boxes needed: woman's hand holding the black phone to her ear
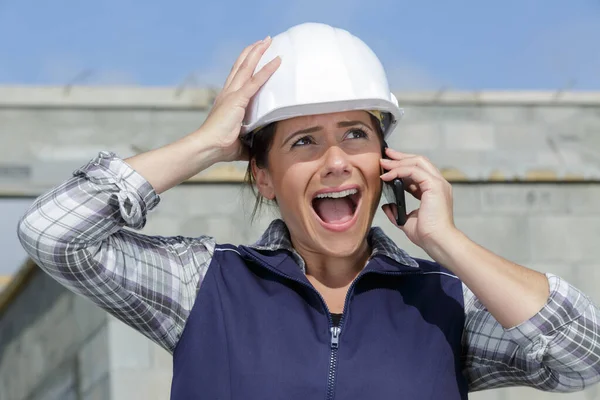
[381,148,457,252]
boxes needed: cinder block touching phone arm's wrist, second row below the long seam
[454,215,530,263]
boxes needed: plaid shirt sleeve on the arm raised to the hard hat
[18,152,215,352]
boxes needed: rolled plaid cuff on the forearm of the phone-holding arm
[506,273,591,361]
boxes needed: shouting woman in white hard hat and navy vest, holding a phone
[19,24,600,399]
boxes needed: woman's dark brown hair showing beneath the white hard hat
[244,114,383,221]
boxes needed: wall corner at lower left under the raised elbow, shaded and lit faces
[0,271,172,400]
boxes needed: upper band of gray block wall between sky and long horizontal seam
[0,87,600,194]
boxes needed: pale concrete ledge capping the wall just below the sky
[0,85,600,109]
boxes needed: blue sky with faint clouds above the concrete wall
[0,0,600,90]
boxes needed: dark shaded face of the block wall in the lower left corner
[0,273,109,400]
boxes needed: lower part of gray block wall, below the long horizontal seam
[0,183,600,400]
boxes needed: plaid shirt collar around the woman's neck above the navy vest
[249,219,419,272]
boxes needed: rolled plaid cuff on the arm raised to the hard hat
[73,151,160,229]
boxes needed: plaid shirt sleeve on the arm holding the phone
[463,274,600,392]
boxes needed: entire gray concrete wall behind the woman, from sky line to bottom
[0,88,600,400]
